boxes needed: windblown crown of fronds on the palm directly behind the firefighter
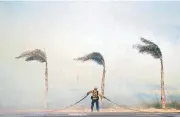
[74,52,105,66]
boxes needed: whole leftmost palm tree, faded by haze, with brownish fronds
[16,49,48,108]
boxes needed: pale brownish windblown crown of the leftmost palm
[16,49,47,63]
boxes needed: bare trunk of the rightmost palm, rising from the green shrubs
[160,58,166,109]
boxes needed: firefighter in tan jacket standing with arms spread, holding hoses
[87,87,103,112]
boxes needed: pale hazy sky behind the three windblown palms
[0,2,180,108]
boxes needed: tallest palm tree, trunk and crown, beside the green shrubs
[133,38,166,109]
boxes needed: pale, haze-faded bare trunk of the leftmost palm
[44,61,48,108]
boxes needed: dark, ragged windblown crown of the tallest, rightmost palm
[133,38,162,59]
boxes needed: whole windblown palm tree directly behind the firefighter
[74,52,106,100]
